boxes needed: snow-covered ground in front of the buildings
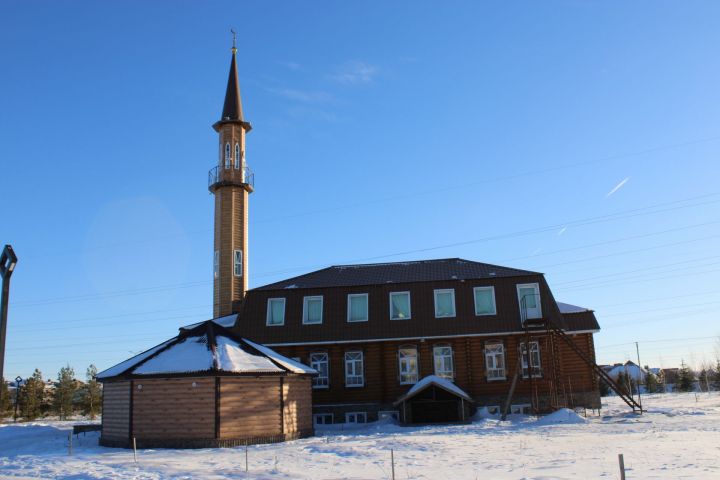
[0,393,720,480]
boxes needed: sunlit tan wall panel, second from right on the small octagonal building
[220,377,283,438]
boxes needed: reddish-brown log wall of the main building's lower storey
[275,334,596,405]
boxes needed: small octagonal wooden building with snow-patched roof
[98,315,316,448]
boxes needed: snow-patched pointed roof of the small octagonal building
[98,320,317,379]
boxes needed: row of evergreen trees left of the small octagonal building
[0,365,102,421]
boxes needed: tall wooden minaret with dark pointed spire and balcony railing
[208,38,254,317]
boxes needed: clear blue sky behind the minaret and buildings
[0,1,720,378]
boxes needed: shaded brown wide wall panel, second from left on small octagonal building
[133,377,215,440]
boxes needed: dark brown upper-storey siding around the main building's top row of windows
[235,275,564,346]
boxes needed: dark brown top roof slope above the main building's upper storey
[254,258,537,290]
